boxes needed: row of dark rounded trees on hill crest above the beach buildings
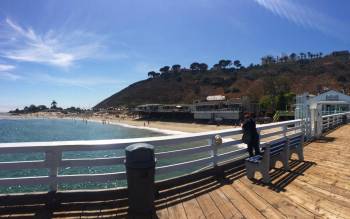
[148,59,244,78]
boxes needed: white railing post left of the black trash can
[45,150,62,192]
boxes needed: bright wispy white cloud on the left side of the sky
[0,18,109,67]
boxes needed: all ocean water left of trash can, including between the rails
[0,114,165,193]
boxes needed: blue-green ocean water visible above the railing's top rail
[0,116,164,143]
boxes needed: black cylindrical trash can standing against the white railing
[125,143,156,217]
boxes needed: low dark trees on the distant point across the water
[9,100,83,114]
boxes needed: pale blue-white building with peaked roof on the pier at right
[295,90,350,119]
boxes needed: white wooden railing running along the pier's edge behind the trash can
[0,120,305,191]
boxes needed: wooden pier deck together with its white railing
[0,112,350,218]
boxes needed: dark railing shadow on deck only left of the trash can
[0,187,127,218]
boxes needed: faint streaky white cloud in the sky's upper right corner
[254,0,347,38]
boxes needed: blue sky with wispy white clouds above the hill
[0,0,350,111]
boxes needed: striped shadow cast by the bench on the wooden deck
[252,160,317,192]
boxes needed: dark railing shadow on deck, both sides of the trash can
[0,160,245,218]
